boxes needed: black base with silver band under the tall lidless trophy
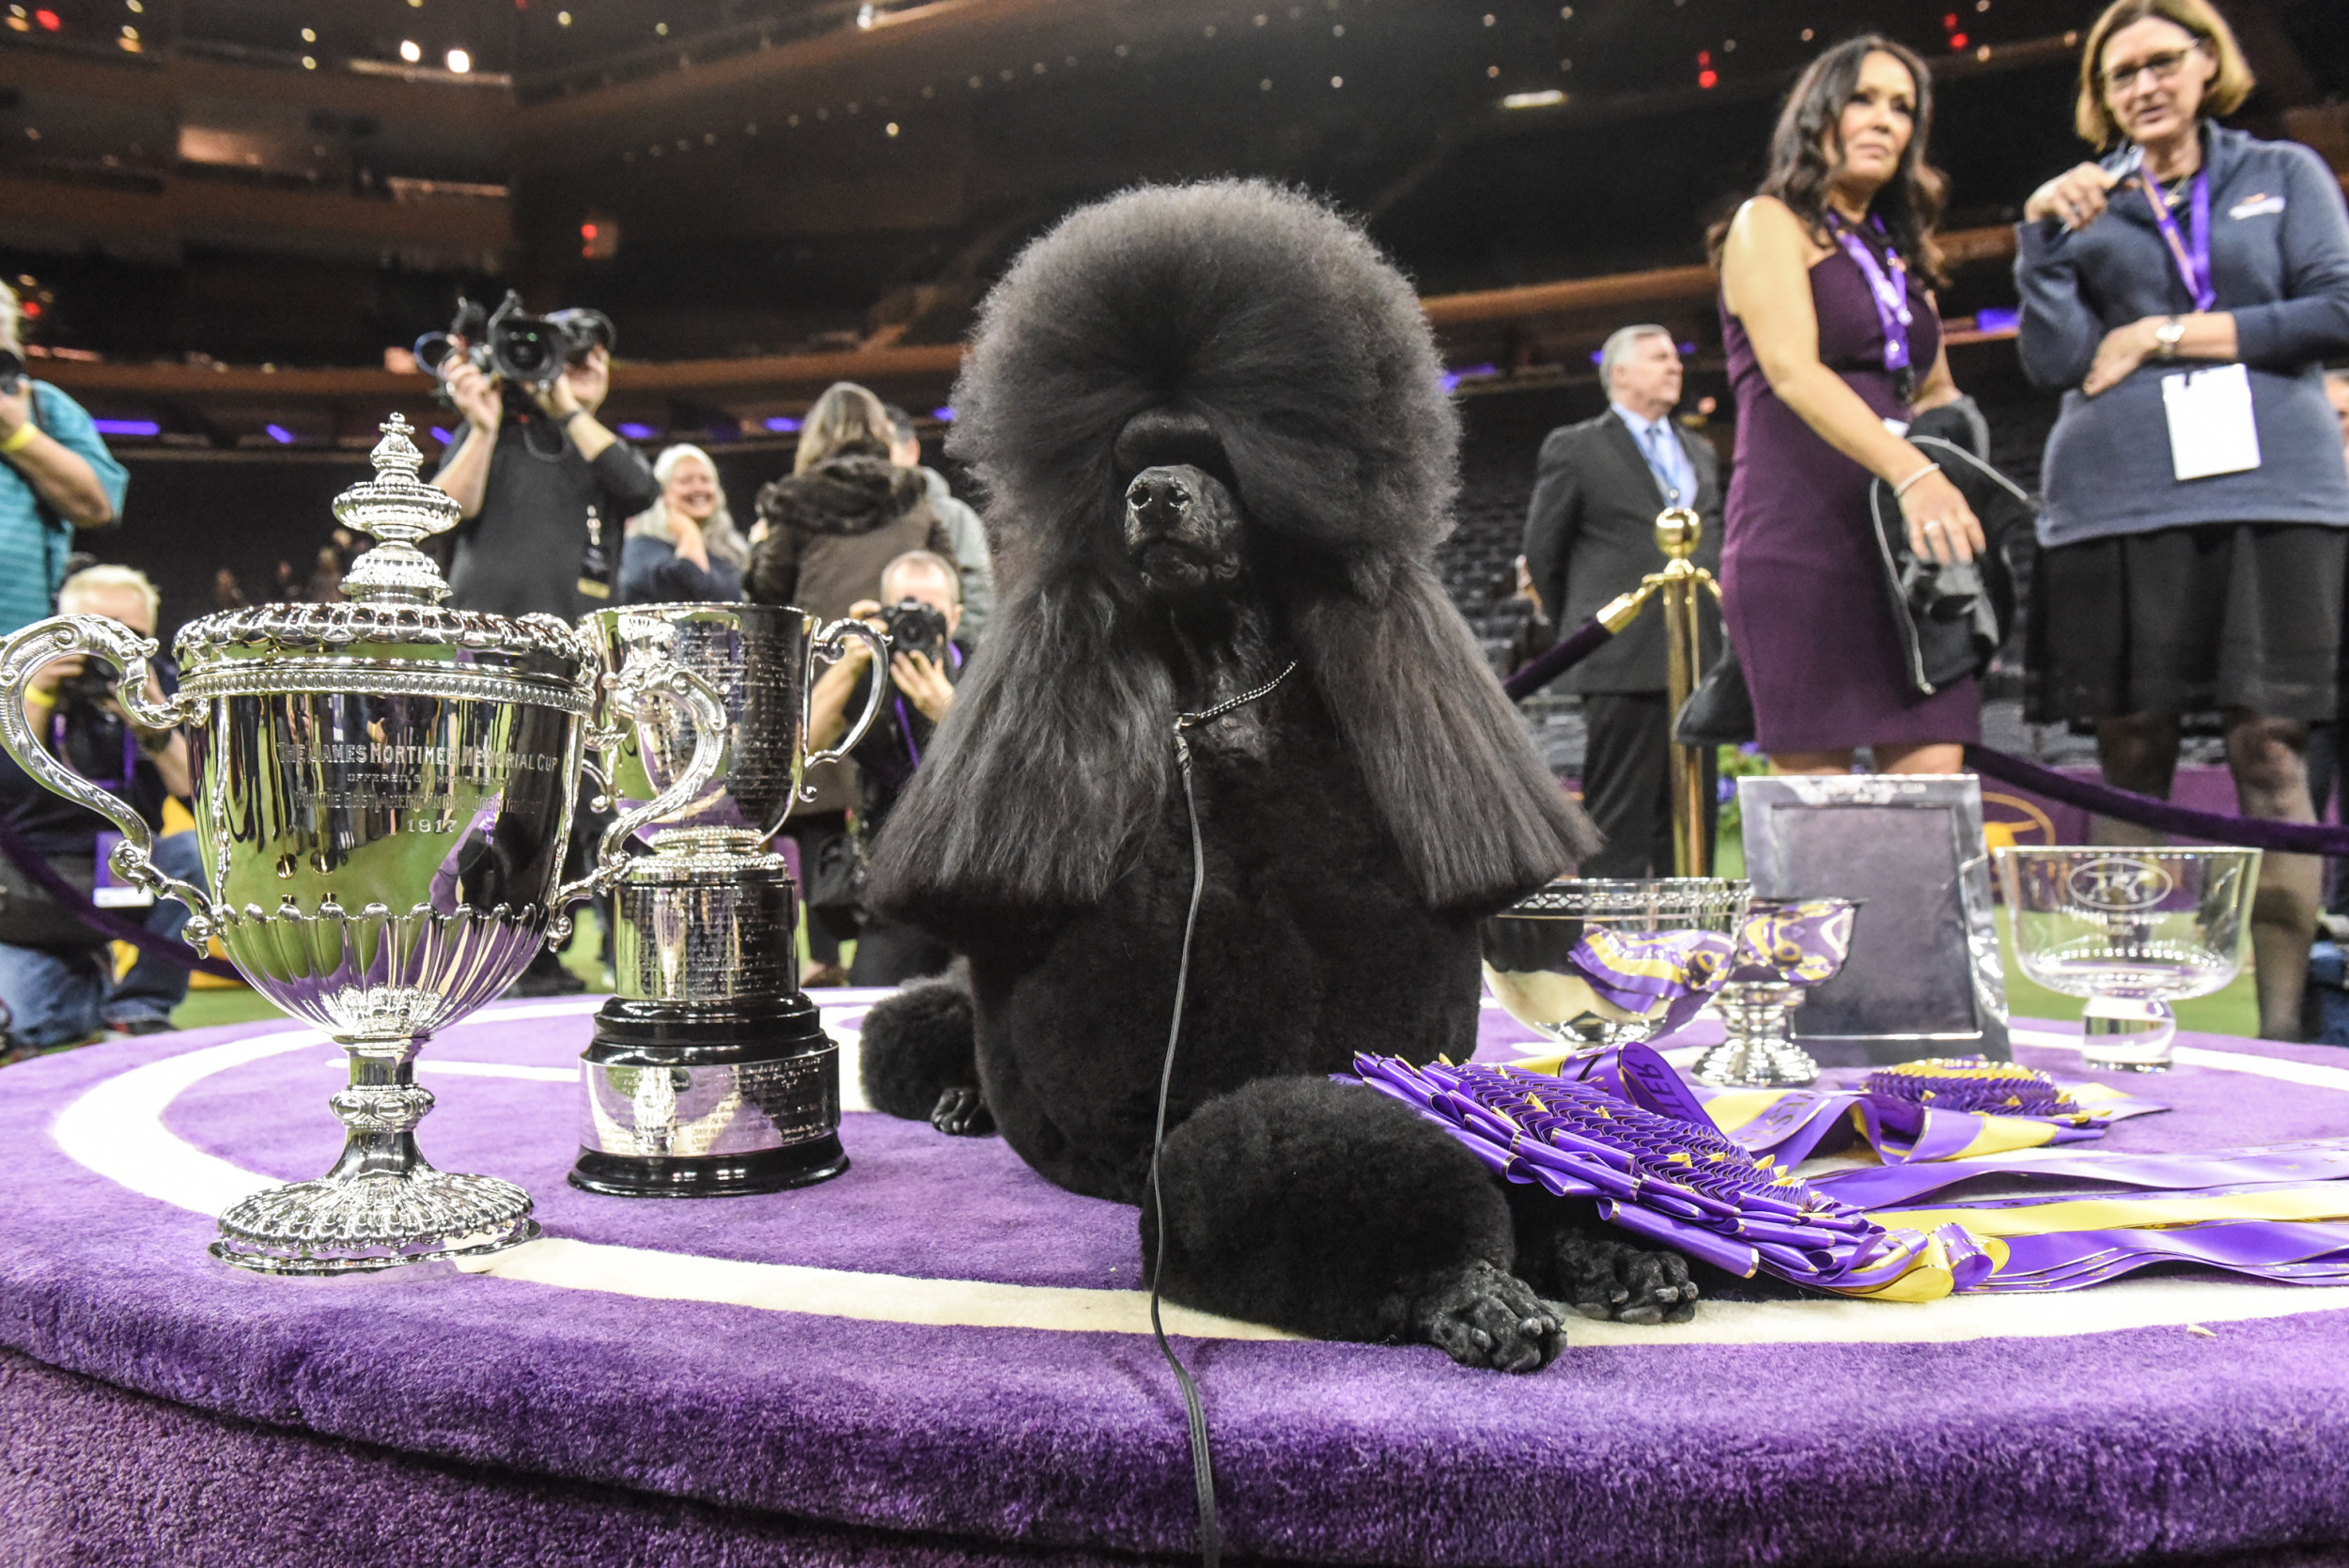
[571,990,848,1197]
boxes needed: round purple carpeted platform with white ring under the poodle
[0,993,2349,1568]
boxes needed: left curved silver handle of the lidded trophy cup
[0,615,216,951]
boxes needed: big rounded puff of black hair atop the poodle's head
[949,180,1459,594]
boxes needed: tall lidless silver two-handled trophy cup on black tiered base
[571,603,888,1197]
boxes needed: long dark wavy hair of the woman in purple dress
[1705,33,1950,287]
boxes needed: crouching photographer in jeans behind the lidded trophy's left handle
[0,566,205,1049]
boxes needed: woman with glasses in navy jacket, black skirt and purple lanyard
[2015,0,2349,1040]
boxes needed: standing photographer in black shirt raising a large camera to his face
[418,296,661,622]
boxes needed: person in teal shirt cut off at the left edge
[0,284,130,631]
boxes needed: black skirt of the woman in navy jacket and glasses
[2025,523,2349,723]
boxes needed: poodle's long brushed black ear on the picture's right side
[1290,561,1600,910]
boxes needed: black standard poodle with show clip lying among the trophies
[864,180,1696,1371]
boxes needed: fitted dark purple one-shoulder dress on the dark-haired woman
[1722,251,1983,752]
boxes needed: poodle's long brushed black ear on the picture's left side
[867,573,1174,929]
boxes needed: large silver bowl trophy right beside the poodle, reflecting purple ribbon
[1483,876,1748,1051]
